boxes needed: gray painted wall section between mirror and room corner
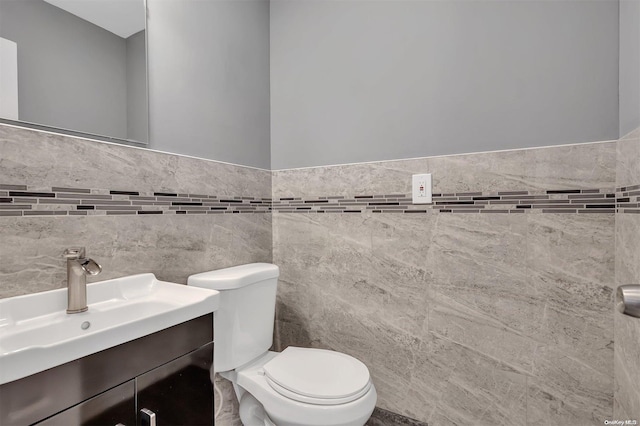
[147,0,270,169]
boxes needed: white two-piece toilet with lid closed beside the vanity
[187,263,377,426]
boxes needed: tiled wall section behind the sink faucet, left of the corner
[0,125,271,297]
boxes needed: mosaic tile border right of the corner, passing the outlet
[273,185,640,214]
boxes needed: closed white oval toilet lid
[263,346,371,404]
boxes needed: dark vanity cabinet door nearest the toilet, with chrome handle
[136,342,213,426]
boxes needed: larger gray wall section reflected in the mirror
[0,0,127,138]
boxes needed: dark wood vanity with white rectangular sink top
[0,274,219,426]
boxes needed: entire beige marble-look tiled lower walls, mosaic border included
[0,122,640,425]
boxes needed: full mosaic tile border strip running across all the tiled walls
[0,184,640,217]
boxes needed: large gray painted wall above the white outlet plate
[271,0,618,169]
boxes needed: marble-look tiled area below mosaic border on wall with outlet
[274,201,613,425]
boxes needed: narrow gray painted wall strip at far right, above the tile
[620,0,640,137]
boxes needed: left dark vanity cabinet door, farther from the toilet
[37,380,136,426]
